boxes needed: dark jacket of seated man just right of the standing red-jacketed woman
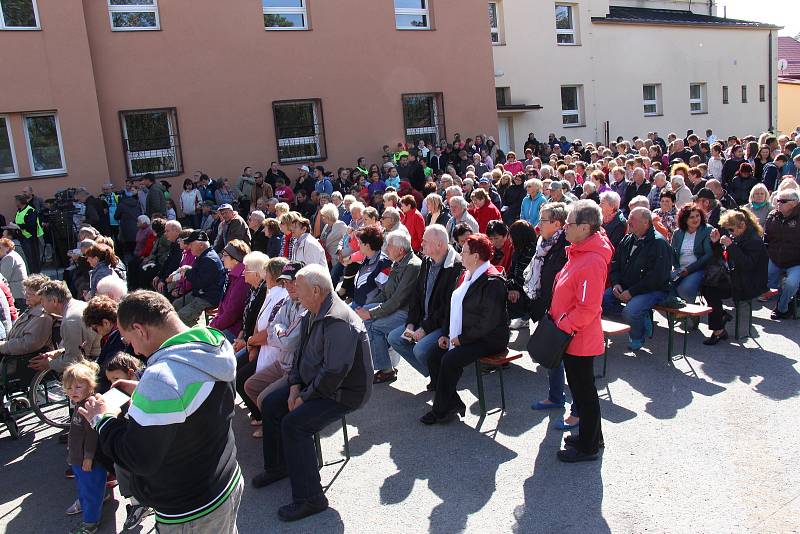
[610,226,672,297]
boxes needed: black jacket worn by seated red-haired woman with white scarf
[444,266,510,352]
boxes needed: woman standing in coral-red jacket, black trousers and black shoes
[550,200,614,462]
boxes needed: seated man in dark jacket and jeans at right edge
[764,189,800,319]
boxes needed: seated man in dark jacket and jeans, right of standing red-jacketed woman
[603,207,672,350]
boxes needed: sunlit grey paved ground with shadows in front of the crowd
[0,308,800,534]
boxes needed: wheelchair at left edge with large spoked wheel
[0,324,70,439]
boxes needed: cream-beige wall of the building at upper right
[493,0,776,149]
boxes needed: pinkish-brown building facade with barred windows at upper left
[0,0,497,217]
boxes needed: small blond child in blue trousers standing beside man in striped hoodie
[62,360,107,534]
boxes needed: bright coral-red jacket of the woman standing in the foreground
[550,232,614,356]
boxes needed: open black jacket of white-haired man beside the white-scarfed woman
[407,249,463,334]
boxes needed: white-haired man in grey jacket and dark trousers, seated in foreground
[253,264,372,521]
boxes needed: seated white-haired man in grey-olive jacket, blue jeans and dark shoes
[356,231,422,384]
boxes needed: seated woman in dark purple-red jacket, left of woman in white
[209,239,250,341]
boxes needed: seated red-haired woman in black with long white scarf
[420,234,509,425]
